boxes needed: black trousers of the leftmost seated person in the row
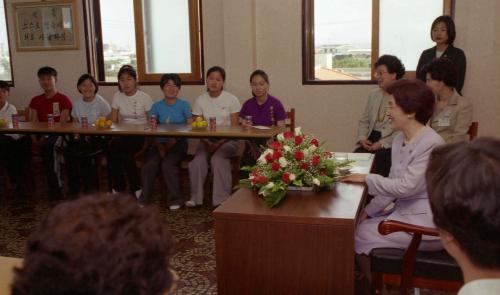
[0,134,31,195]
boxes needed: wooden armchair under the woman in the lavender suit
[370,220,463,294]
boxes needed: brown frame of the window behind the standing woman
[302,0,455,85]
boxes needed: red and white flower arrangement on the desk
[239,127,352,208]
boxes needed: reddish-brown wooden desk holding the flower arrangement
[214,157,373,295]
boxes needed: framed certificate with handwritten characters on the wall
[12,0,78,51]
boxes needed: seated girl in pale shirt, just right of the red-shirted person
[64,74,111,196]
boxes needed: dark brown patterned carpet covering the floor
[0,163,217,295]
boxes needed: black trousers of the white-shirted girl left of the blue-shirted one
[109,136,144,192]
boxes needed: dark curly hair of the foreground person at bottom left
[12,195,173,295]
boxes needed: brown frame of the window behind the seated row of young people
[82,0,205,85]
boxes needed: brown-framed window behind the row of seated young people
[85,0,203,84]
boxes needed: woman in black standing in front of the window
[417,15,466,94]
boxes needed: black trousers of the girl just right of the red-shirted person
[64,136,107,195]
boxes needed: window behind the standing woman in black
[302,0,452,84]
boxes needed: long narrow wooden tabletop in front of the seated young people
[0,122,285,139]
